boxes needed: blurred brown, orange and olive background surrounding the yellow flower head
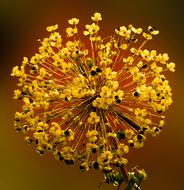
[0,0,184,190]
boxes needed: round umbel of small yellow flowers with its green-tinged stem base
[11,13,175,190]
